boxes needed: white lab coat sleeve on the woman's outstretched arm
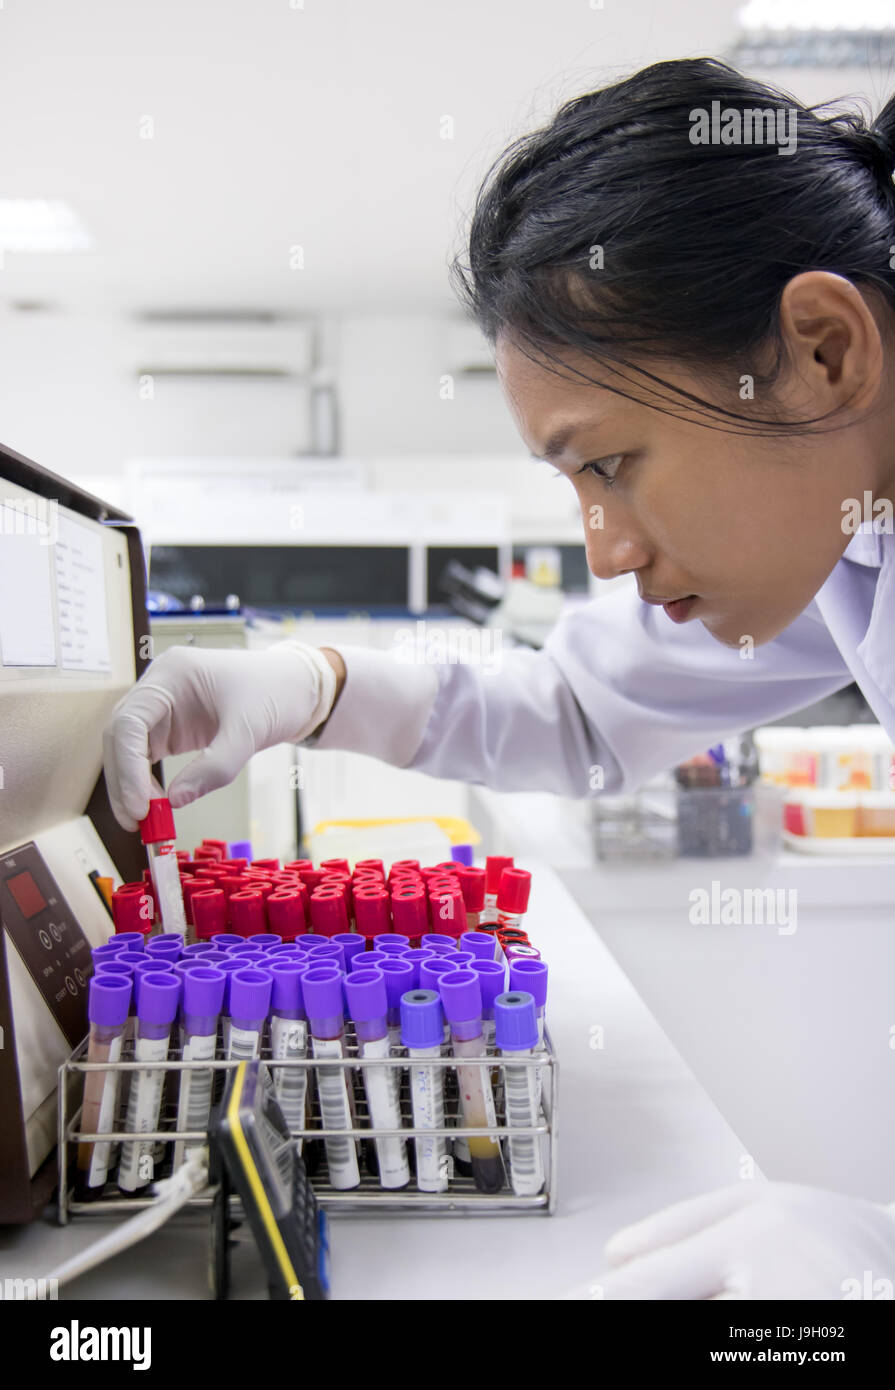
[315,585,852,796]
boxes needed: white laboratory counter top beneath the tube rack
[0,859,746,1300]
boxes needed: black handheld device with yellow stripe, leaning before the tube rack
[208,1062,329,1301]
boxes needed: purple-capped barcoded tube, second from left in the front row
[118,973,181,1193]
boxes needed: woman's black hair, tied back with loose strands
[452,58,895,432]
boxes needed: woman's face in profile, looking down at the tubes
[496,328,873,648]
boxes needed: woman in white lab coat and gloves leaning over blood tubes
[106,60,895,1298]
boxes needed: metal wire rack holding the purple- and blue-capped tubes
[57,1023,559,1225]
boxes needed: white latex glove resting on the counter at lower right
[571,1180,895,1300]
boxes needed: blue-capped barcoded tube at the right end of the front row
[495,990,543,1197]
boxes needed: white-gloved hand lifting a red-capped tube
[103,641,336,830]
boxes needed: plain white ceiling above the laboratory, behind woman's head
[0,0,738,314]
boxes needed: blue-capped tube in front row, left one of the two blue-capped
[400,990,449,1193]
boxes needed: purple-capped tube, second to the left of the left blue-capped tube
[302,965,360,1191]
